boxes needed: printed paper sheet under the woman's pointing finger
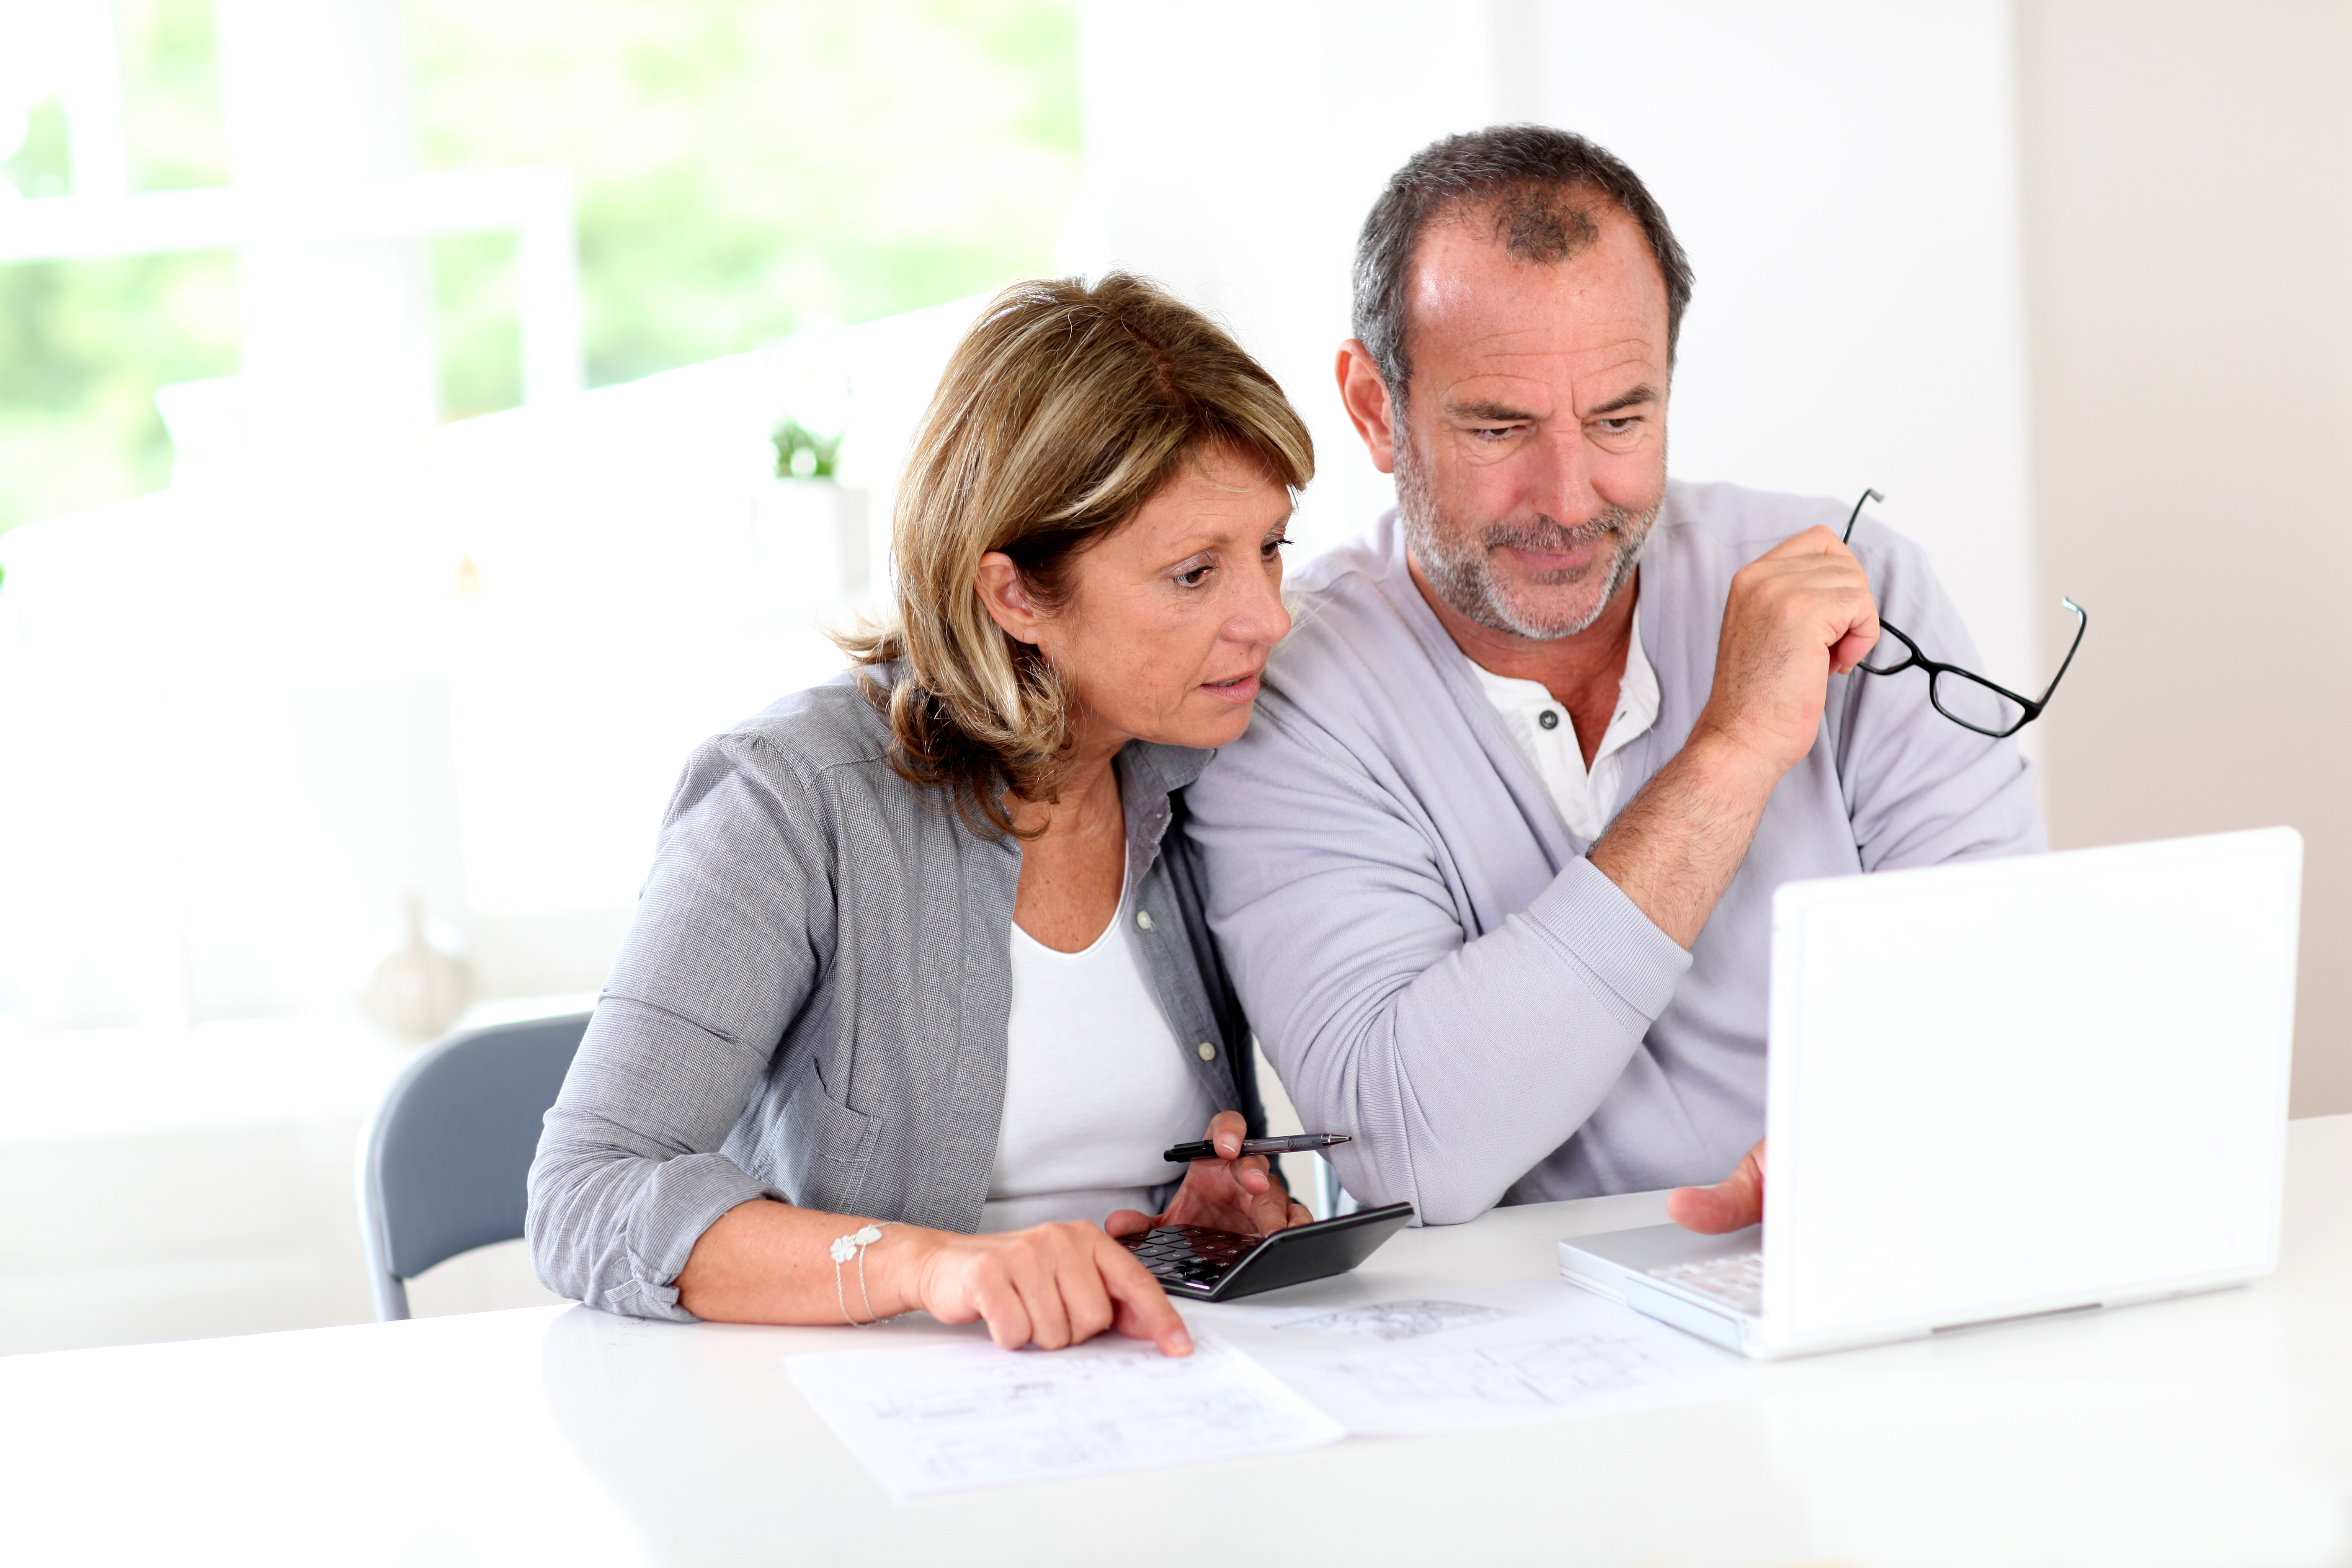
[786,1328,1345,1500]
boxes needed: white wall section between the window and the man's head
[1056,0,1493,550]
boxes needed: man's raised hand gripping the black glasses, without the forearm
[1691,524,1879,781]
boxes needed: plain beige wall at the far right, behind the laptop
[2020,0,2352,1117]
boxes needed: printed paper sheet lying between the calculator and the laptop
[1192,1279,1767,1436]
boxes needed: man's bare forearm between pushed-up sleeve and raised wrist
[1588,733,1783,950]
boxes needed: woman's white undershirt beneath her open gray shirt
[981,860,1216,1232]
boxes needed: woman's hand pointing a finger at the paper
[873,1222,1192,1357]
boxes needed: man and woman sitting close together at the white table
[529,127,2042,1354]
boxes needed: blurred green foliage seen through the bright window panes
[0,0,1080,529]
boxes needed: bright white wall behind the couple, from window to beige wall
[1063,0,2039,684]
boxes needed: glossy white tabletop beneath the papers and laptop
[0,1117,2352,1568]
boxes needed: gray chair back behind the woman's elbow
[360,1013,588,1323]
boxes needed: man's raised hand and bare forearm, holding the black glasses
[1588,526,1879,947]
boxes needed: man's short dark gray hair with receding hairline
[1355,124,1691,407]
